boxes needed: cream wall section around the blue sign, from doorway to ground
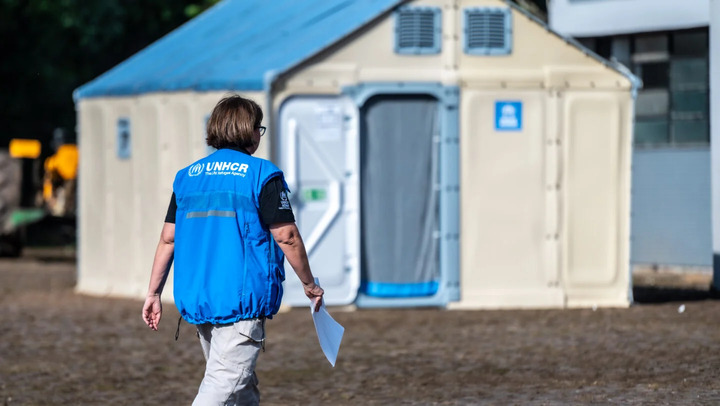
[460,89,563,307]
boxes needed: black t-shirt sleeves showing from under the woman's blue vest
[165,176,295,226]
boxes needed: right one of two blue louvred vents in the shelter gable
[464,7,512,55]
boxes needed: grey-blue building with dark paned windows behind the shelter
[548,0,720,279]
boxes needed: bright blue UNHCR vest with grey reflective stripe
[173,149,287,324]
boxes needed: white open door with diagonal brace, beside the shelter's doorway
[277,97,360,306]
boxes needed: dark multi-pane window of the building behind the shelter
[586,28,710,147]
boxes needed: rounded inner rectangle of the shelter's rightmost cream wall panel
[565,98,620,286]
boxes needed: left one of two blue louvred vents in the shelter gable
[395,7,442,54]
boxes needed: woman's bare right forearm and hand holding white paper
[270,223,325,311]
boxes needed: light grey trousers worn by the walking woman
[193,318,265,406]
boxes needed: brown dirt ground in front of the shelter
[0,253,720,405]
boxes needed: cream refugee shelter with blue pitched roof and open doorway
[75,0,639,308]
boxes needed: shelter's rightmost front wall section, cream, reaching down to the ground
[562,92,632,306]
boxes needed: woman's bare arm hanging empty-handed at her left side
[142,223,175,331]
